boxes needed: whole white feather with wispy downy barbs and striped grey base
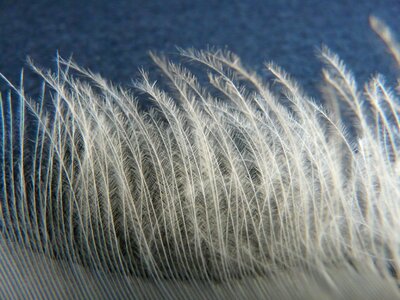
[0,17,400,299]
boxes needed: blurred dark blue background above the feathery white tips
[0,0,400,95]
